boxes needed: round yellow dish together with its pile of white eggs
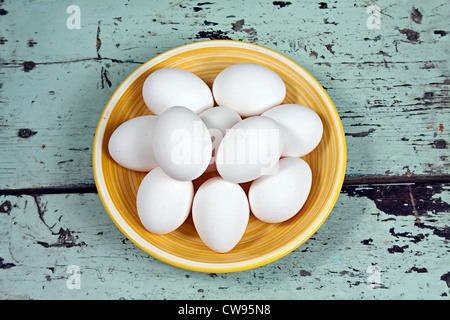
[93,40,346,273]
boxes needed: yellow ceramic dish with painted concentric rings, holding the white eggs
[93,40,346,272]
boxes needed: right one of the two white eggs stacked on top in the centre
[216,116,284,183]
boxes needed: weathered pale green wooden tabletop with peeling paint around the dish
[0,0,450,300]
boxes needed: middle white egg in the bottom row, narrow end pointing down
[192,177,250,253]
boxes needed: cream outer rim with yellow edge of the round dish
[92,40,347,273]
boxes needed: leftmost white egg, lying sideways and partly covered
[108,116,158,172]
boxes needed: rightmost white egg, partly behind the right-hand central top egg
[262,104,323,157]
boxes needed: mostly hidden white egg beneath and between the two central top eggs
[200,106,242,172]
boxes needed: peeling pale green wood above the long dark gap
[0,0,450,190]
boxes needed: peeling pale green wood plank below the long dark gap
[0,184,450,300]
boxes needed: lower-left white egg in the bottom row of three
[136,167,194,234]
